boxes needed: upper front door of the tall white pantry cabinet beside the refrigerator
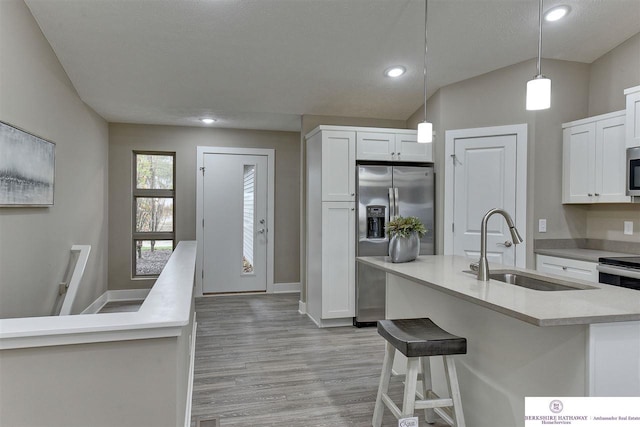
[322,131,356,202]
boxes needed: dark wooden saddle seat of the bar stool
[378,318,467,357]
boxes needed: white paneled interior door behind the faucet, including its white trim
[445,125,527,267]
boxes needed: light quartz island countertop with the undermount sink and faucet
[357,255,640,326]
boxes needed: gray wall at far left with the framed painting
[0,0,108,318]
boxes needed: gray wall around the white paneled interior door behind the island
[408,60,589,267]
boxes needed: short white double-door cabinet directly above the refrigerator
[356,129,433,162]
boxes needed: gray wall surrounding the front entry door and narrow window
[109,123,300,289]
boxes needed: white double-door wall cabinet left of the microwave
[562,111,631,203]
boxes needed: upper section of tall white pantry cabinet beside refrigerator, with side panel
[307,128,356,202]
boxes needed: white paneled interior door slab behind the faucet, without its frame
[452,134,520,265]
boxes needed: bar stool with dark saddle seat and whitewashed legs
[373,318,467,427]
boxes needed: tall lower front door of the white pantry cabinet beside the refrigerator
[320,202,356,319]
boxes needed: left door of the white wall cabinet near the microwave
[562,123,596,203]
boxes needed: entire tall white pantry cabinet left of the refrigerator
[306,127,356,327]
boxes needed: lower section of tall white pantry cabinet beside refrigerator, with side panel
[307,202,356,327]
